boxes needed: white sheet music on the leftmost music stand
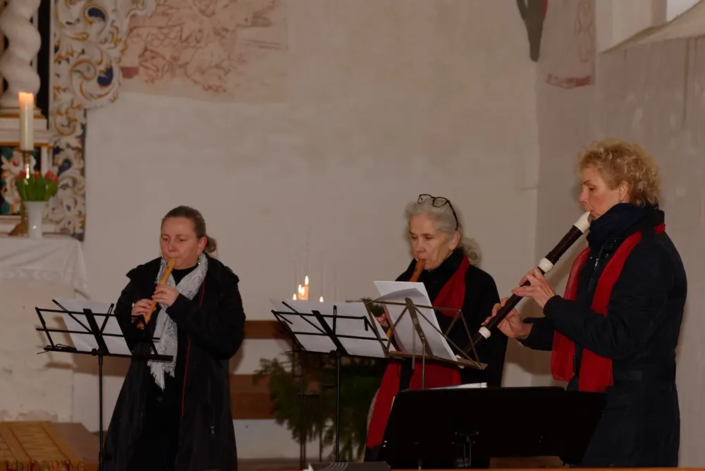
[54,298,131,355]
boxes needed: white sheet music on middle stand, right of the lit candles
[270,299,394,358]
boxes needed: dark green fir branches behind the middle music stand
[255,298,387,461]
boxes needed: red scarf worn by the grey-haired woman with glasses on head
[367,257,470,448]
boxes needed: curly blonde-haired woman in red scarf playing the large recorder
[486,140,687,468]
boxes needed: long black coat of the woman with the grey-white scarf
[105,257,245,471]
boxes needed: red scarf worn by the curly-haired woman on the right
[551,224,666,392]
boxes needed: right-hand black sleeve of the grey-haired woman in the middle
[459,270,507,387]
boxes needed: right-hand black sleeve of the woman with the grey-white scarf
[166,278,245,359]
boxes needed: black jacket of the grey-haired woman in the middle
[397,248,507,389]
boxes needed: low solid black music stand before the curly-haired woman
[379,387,604,469]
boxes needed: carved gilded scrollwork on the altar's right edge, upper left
[49,0,170,237]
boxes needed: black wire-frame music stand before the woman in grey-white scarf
[35,299,173,471]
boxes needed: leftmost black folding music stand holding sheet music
[35,299,173,471]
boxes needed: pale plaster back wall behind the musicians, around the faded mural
[80,0,538,457]
